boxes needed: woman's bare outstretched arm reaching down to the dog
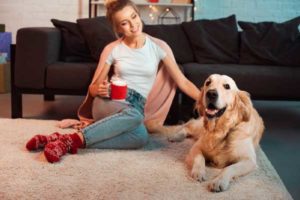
[163,55,200,100]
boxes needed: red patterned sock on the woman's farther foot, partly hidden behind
[26,132,61,151]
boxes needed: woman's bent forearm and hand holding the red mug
[89,63,111,97]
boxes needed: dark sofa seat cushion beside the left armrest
[46,62,97,90]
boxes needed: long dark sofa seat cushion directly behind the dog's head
[182,63,300,99]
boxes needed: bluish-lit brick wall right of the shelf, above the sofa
[195,0,300,22]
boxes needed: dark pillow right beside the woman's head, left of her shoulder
[77,17,116,61]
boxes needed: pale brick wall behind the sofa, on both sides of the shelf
[0,0,300,42]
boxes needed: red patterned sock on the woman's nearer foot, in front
[44,133,83,163]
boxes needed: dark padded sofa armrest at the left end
[14,27,61,89]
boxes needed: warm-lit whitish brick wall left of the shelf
[0,0,88,43]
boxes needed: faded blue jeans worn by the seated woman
[82,89,148,149]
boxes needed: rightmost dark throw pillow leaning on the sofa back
[238,17,300,66]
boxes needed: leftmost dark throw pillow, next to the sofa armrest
[51,19,93,62]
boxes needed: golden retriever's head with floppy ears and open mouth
[196,74,252,121]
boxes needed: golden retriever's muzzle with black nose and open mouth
[205,90,226,119]
